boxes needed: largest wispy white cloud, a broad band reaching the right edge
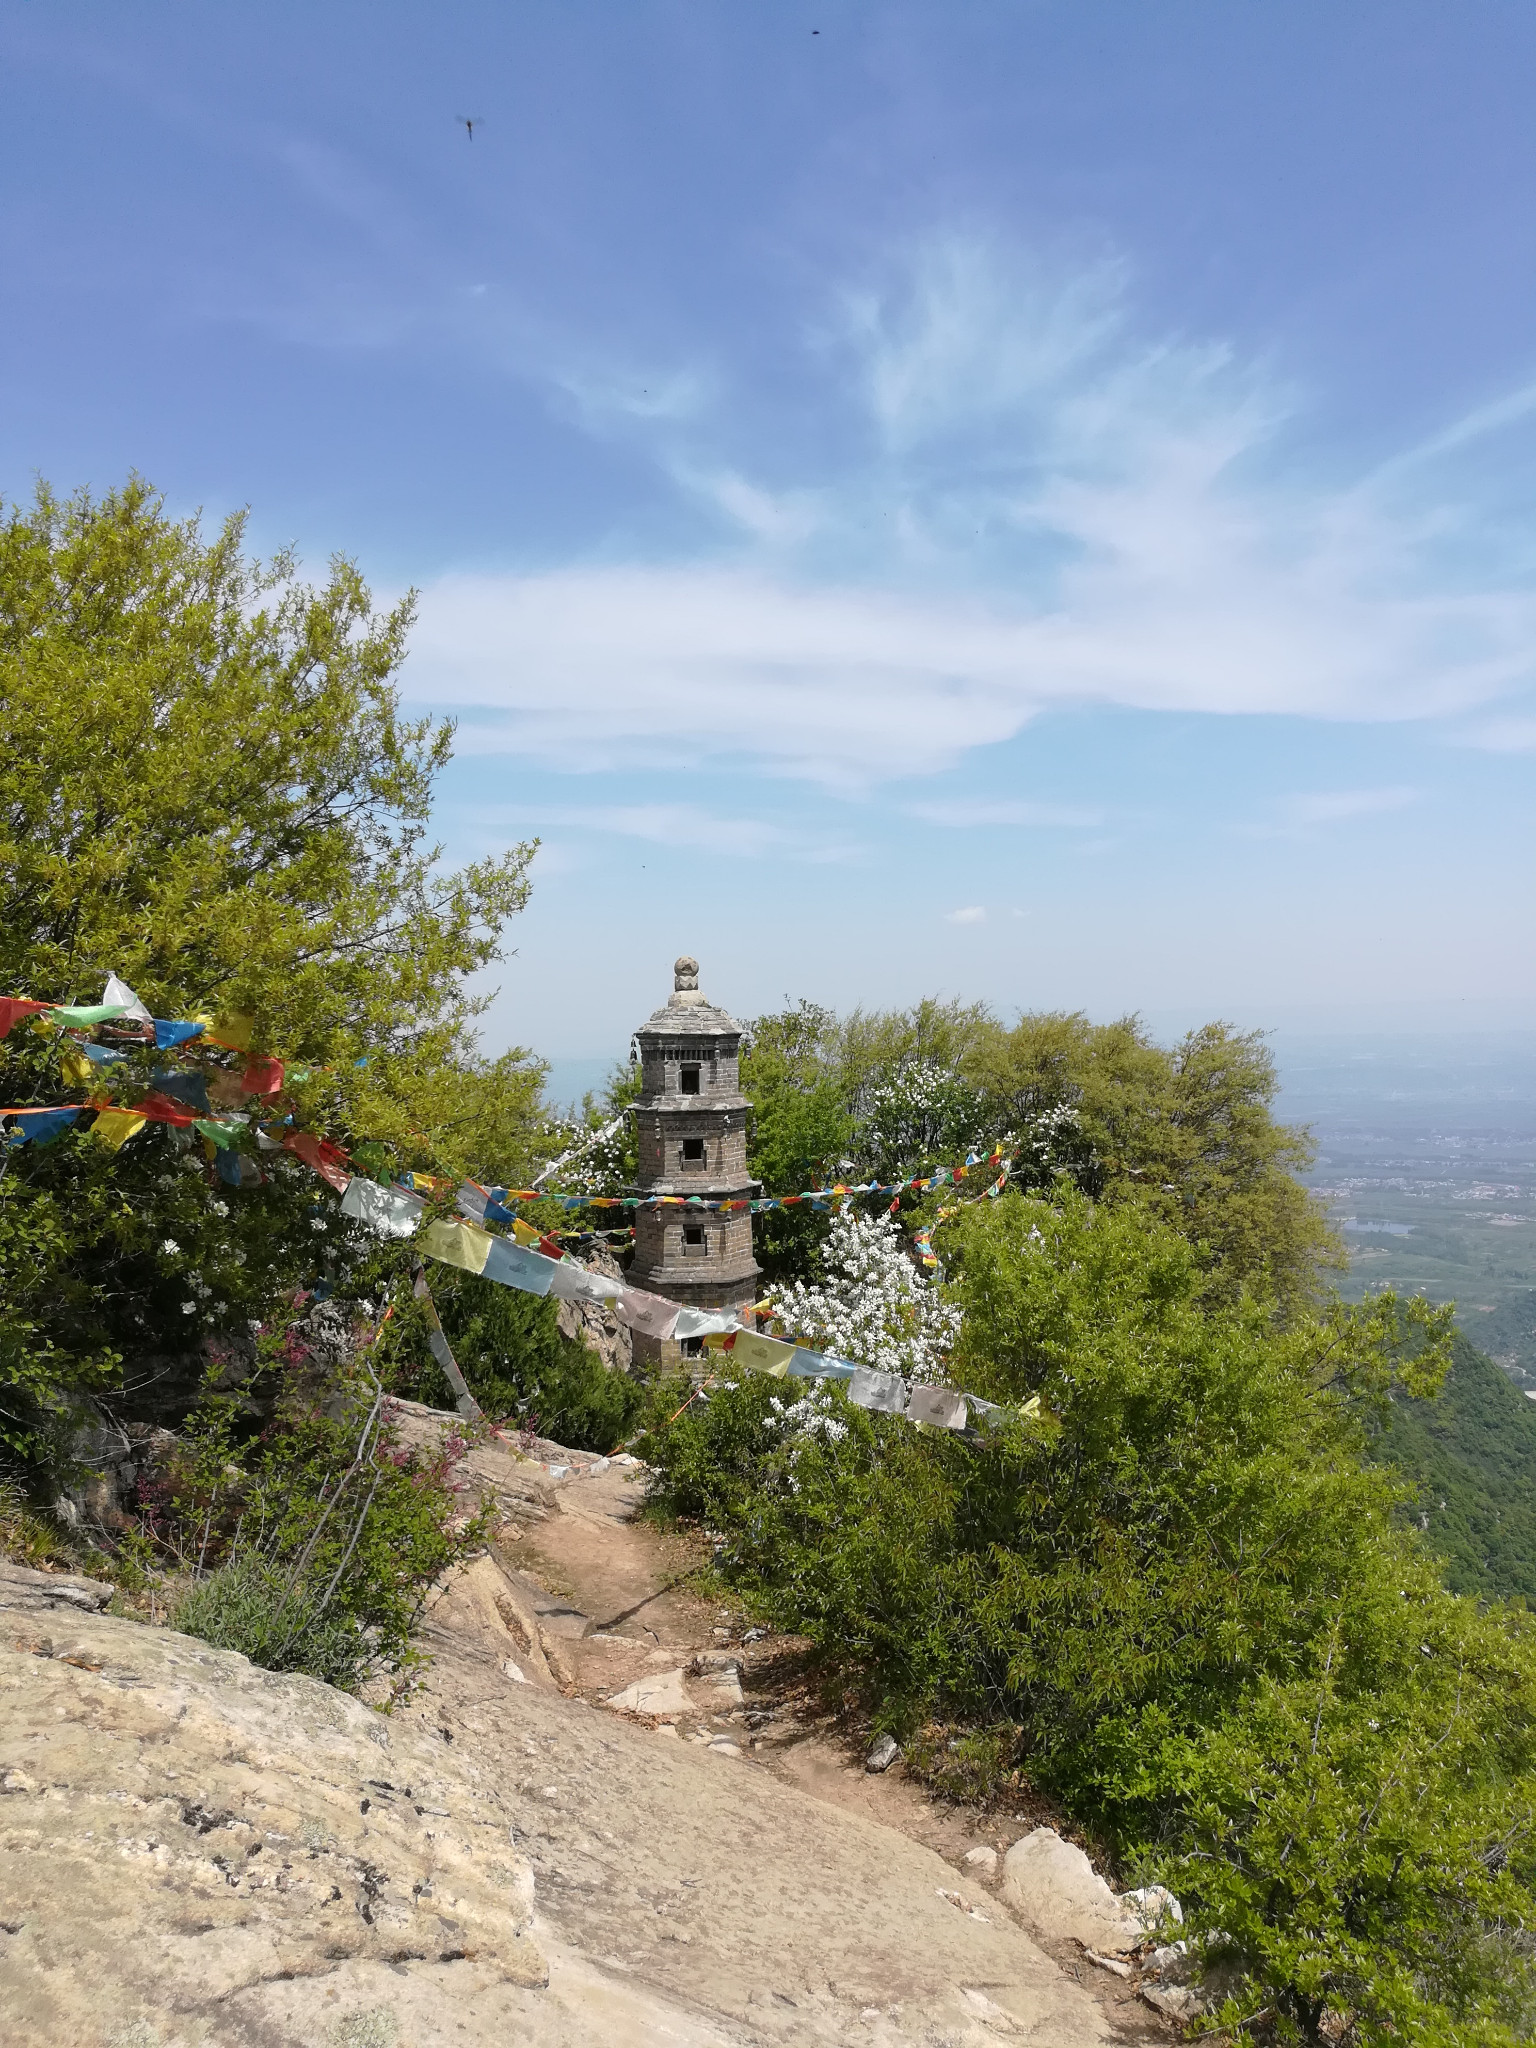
[406,240,1536,782]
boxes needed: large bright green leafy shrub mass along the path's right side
[653,1192,1536,2044]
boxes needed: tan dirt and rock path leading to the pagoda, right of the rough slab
[385,1409,1169,2048]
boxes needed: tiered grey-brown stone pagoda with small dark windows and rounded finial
[629,954,762,1366]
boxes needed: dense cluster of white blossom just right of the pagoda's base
[774,1208,961,1382]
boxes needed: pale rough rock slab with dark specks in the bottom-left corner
[0,1597,547,2048]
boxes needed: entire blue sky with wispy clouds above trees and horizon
[0,0,1536,1061]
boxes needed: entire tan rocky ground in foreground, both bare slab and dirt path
[0,1403,1188,2048]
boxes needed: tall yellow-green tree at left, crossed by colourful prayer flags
[0,481,541,1446]
